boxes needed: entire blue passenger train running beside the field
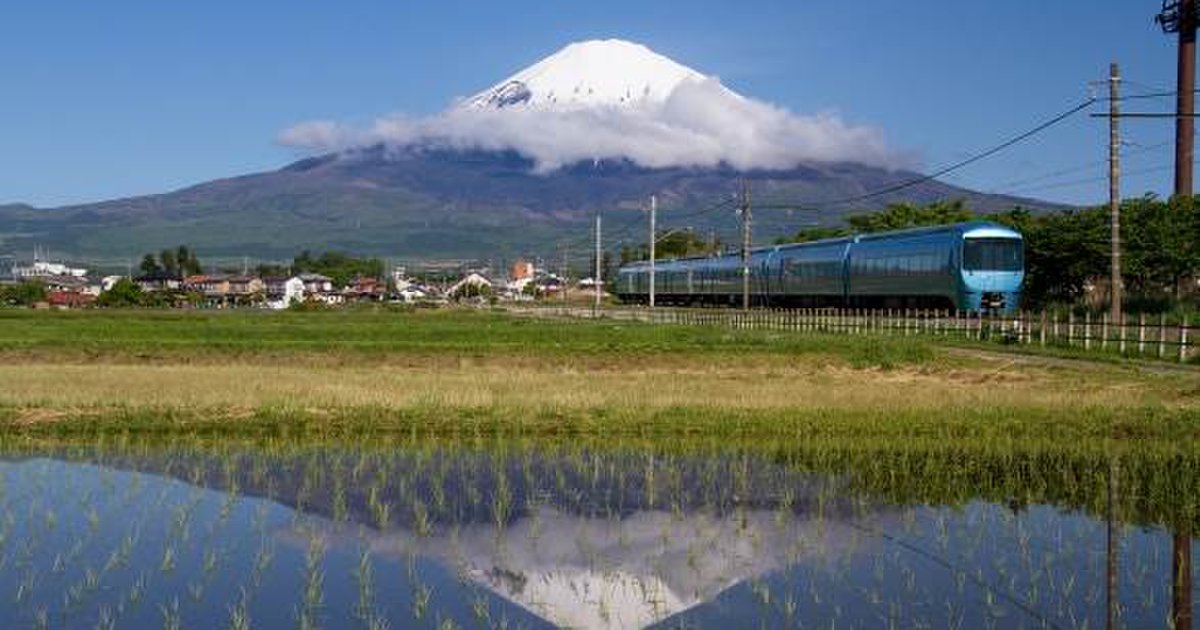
[616,221,1025,312]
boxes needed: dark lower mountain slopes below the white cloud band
[0,146,1044,259]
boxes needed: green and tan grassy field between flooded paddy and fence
[0,311,1200,439]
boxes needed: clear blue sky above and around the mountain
[0,0,1175,205]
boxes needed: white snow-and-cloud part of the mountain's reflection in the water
[350,509,878,629]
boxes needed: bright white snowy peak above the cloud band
[461,40,707,109]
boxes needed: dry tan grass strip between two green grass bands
[0,350,1200,410]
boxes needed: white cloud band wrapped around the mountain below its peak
[280,79,901,172]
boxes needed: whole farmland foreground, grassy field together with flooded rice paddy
[0,306,1200,629]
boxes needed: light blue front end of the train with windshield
[959,223,1025,313]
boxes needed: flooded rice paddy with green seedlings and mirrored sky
[0,438,1200,628]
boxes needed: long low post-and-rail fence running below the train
[510,306,1200,362]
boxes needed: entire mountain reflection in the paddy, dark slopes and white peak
[49,451,887,628]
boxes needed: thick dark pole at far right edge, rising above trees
[1154,0,1196,197]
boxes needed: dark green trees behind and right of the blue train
[784,196,1200,310]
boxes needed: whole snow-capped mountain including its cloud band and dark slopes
[0,40,1049,265]
